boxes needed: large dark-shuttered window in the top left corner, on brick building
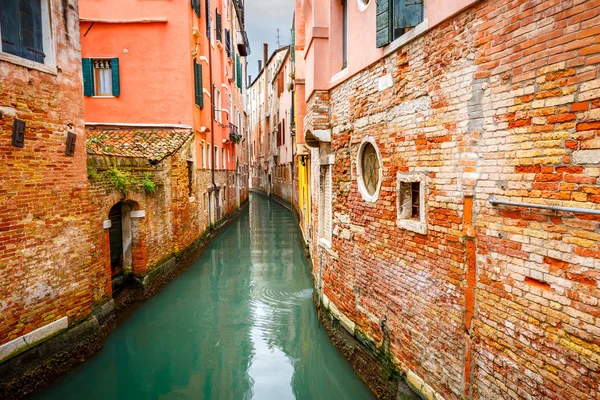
[0,0,46,64]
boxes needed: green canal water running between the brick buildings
[38,195,372,400]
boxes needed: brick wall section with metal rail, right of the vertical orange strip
[473,0,600,399]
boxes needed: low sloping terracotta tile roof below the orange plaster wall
[86,129,194,162]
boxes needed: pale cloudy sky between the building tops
[244,0,295,79]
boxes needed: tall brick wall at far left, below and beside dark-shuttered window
[0,1,102,345]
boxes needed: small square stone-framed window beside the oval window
[397,174,427,234]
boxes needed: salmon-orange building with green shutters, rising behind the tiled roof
[79,0,250,216]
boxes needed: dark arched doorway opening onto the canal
[108,201,136,292]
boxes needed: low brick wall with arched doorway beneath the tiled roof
[89,141,247,284]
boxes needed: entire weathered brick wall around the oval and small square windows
[304,0,600,399]
